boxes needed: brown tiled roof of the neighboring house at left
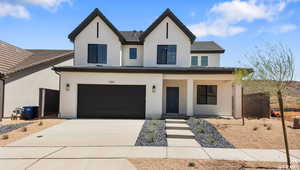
[0,41,74,78]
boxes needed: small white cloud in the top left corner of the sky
[0,2,30,18]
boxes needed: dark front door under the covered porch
[166,87,179,113]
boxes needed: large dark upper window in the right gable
[157,45,176,64]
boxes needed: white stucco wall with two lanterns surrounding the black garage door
[60,72,163,118]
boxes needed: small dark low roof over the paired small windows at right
[191,41,225,53]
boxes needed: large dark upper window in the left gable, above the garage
[88,44,107,64]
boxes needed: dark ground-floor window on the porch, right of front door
[197,85,217,105]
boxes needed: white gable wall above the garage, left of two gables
[74,17,122,66]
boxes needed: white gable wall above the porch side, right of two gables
[144,17,191,67]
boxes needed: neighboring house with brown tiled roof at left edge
[0,41,74,117]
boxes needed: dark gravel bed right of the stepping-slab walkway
[187,118,234,148]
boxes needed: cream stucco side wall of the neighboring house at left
[4,59,73,117]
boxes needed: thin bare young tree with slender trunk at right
[237,43,295,168]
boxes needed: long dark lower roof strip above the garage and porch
[53,66,251,74]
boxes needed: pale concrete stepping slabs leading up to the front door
[166,119,200,147]
